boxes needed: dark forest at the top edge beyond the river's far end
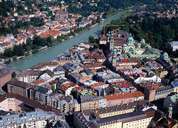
[66,0,156,16]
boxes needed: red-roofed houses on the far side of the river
[0,3,101,53]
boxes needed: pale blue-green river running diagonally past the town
[9,11,128,70]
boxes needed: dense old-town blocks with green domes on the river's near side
[1,30,178,128]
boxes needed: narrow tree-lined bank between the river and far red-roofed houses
[0,19,98,64]
